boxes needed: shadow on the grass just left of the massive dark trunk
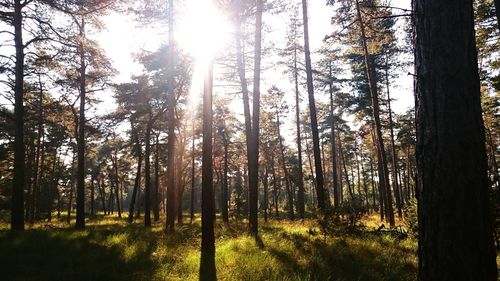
[268,228,416,281]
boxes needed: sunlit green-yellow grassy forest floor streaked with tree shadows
[0,213,417,281]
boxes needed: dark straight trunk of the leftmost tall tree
[10,0,26,230]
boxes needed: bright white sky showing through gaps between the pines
[94,0,414,129]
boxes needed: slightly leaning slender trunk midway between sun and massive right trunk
[302,0,326,213]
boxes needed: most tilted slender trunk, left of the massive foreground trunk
[356,0,396,227]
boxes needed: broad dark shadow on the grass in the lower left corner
[0,226,154,281]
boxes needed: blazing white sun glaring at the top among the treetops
[175,0,233,63]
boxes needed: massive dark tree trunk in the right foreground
[414,0,498,280]
